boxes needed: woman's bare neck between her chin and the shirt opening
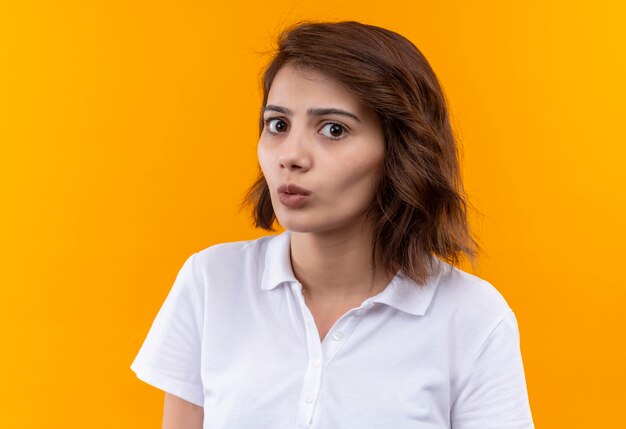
[291,217,393,299]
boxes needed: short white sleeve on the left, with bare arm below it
[130,255,204,406]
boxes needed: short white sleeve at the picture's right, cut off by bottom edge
[450,311,534,429]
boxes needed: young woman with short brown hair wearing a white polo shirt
[131,22,533,429]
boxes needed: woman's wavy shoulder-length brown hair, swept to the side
[243,21,480,285]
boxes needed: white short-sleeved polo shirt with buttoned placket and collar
[131,231,534,429]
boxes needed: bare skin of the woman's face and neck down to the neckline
[258,65,392,340]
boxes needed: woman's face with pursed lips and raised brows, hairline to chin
[258,65,385,232]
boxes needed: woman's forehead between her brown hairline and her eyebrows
[267,64,366,111]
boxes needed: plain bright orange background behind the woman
[0,0,626,429]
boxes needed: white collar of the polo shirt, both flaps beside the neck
[261,230,443,316]
